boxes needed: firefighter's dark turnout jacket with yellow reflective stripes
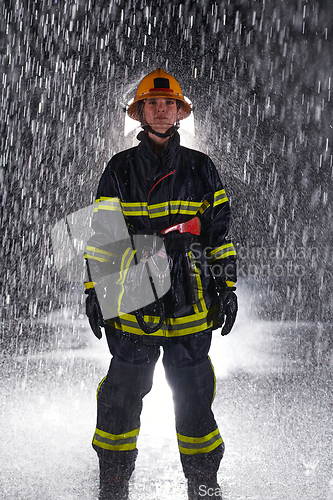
[86,132,236,340]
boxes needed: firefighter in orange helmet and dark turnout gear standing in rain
[85,68,237,500]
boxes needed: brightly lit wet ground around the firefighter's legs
[0,304,333,500]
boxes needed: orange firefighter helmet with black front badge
[127,68,191,121]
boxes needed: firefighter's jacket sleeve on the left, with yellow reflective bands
[85,160,135,289]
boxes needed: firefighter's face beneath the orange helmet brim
[143,97,178,134]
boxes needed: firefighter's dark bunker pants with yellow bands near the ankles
[93,327,224,479]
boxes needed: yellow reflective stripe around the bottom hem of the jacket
[107,307,217,337]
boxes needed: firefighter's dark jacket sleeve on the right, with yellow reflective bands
[197,159,237,288]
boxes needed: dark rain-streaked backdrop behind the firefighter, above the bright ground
[0,0,333,325]
